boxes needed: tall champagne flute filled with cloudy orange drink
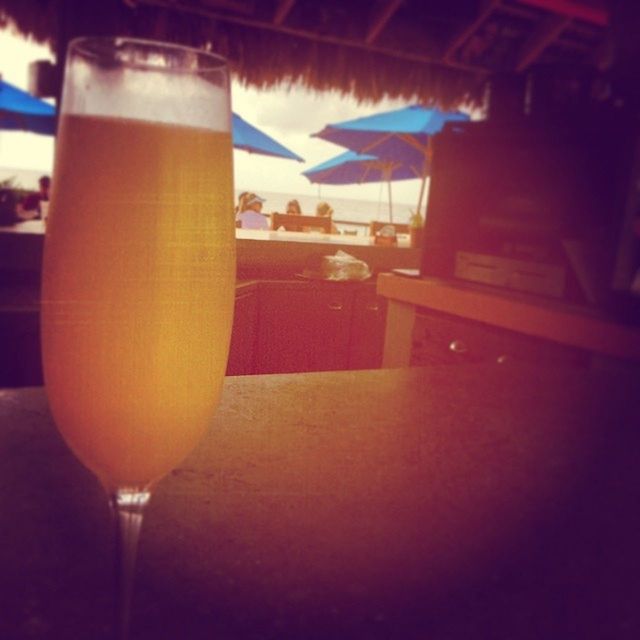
[42,38,235,638]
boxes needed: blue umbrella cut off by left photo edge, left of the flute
[0,80,56,135]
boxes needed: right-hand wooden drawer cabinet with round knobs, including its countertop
[377,274,640,370]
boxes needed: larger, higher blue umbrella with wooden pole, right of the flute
[313,105,469,214]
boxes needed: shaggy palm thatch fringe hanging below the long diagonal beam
[0,0,484,109]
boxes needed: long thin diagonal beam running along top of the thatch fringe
[132,0,490,76]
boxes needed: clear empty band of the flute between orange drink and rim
[62,60,231,132]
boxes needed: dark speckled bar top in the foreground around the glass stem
[0,365,640,640]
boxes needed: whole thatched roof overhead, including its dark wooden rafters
[0,0,632,108]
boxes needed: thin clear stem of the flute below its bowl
[110,487,151,640]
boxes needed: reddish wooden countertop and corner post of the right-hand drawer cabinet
[377,273,640,364]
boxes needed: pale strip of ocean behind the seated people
[0,167,415,235]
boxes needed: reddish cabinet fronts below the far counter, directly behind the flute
[0,281,387,387]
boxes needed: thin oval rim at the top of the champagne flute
[68,36,229,73]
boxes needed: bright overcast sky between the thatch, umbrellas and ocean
[0,31,420,204]
